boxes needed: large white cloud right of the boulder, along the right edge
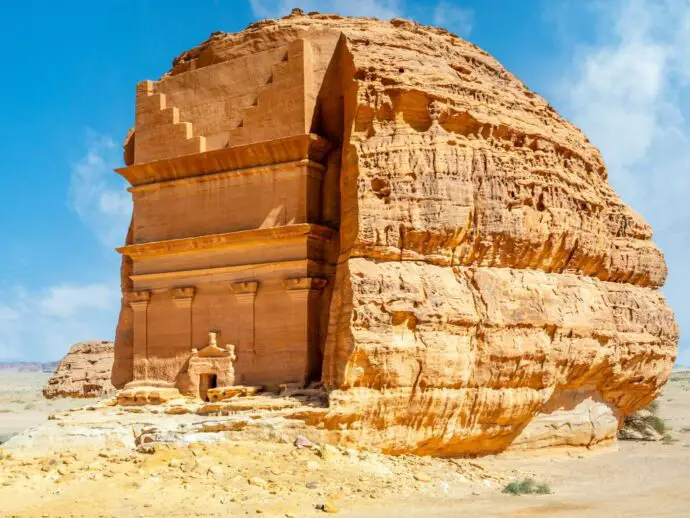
[559,0,690,364]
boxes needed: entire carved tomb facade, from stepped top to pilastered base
[114,28,338,392]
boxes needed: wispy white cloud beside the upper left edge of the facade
[69,130,132,247]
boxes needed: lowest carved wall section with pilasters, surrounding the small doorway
[134,277,322,390]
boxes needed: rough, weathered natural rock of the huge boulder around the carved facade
[110,7,678,456]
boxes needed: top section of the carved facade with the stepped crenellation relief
[134,35,335,163]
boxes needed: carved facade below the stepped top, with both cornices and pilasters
[119,97,337,393]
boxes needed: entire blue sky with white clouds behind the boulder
[0,0,690,364]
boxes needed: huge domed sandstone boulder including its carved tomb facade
[114,7,678,456]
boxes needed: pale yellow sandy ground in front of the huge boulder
[0,375,690,518]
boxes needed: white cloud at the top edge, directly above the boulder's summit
[249,0,402,20]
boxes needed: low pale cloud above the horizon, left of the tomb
[0,282,120,361]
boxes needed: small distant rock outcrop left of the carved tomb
[43,341,115,399]
